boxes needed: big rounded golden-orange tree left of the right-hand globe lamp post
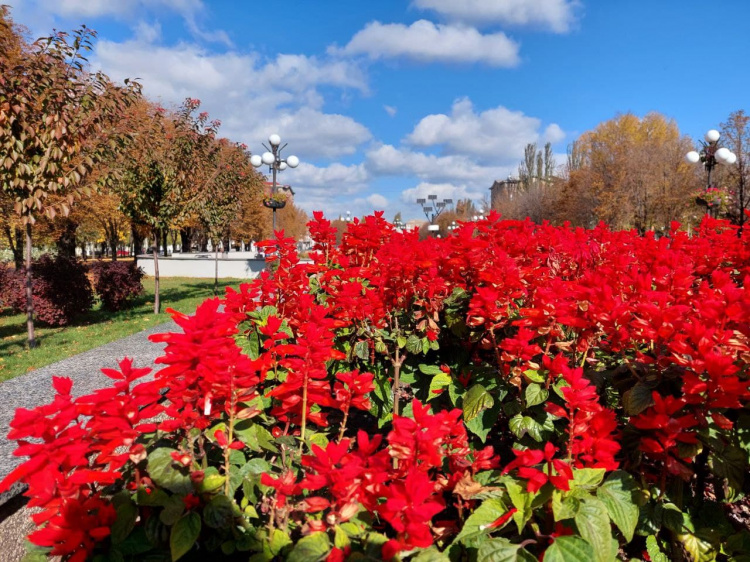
[556,113,697,232]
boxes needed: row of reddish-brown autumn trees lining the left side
[0,7,307,347]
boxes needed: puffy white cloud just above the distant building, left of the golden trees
[405,98,565,164]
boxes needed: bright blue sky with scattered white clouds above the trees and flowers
[5,0,750,219]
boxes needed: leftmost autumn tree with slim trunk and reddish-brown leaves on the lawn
[0,7,139,347]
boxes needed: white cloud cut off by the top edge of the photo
[412,0,580,33]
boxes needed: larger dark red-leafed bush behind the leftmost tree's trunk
[8,254,94,326]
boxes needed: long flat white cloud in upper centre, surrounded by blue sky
[330,20,519,67]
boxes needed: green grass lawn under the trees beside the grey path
[0,277,242,381]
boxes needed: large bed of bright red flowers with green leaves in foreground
[0,215,750,562]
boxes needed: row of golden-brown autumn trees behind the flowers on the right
[495,111,750,232]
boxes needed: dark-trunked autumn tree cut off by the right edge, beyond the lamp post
[721,110,750,235]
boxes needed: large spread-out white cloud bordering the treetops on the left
[92,36,371,160]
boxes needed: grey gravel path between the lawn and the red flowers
[0,322,178,500]
